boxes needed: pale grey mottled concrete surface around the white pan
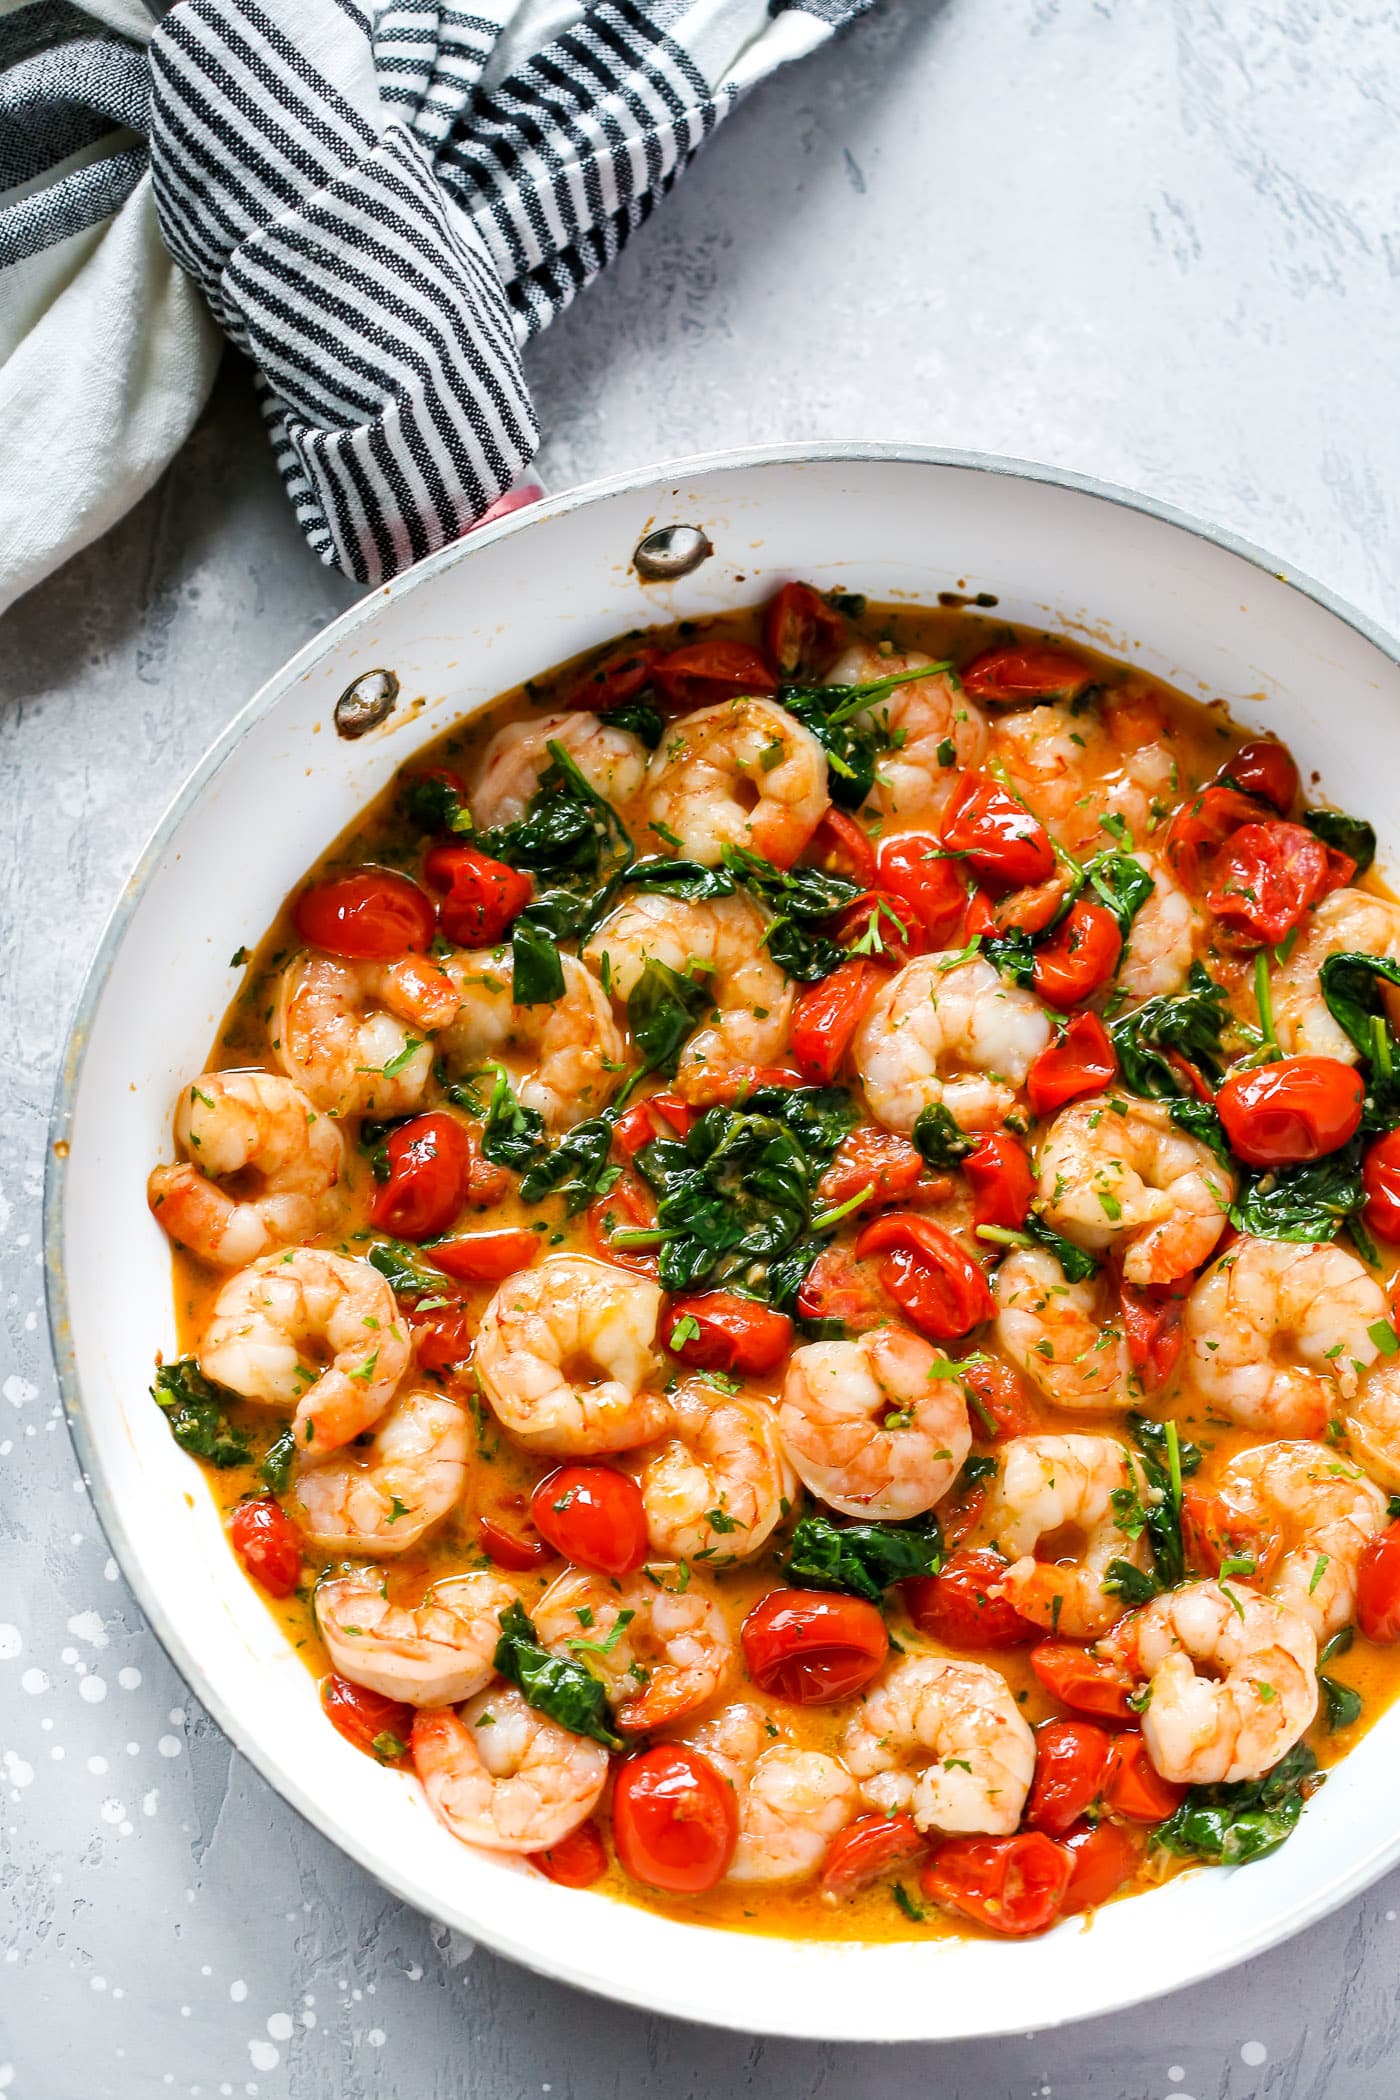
[0,0,1400,2100]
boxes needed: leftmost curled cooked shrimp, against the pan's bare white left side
[147,1071,344,1268]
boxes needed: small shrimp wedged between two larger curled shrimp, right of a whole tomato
[642,1380,798,1567]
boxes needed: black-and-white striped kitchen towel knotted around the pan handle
[0,0,873,605]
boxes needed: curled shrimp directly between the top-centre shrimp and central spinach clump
[584,890,796,1067]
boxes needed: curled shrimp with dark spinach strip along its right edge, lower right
[978,1436,1152,1640]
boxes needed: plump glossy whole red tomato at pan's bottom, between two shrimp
[613,1743,739,1896]
